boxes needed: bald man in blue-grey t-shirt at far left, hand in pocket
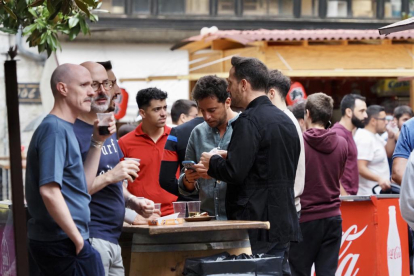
[26,64,115,276]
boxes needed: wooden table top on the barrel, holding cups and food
[123,220,270,235]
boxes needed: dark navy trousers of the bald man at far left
[29,239,105,276]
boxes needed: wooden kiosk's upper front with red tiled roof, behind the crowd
[121,29,414,107]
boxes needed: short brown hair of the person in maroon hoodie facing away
[305,92,333,127]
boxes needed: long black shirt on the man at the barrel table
[208,96,301,243]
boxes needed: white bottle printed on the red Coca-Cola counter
[387,206,402,276]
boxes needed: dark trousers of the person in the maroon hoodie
[289,216,342,276]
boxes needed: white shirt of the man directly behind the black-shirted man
[284,108,305,212]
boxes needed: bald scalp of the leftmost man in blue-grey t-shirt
[50,63,89,97]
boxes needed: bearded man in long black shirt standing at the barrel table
[201,57,302,275]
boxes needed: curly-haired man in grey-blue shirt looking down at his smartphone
[178,76,238,220]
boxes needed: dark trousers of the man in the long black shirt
[251,239,291,276]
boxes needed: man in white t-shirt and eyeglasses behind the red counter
[354,105,395,195]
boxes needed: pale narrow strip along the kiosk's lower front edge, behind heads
[120,69,414,82]
